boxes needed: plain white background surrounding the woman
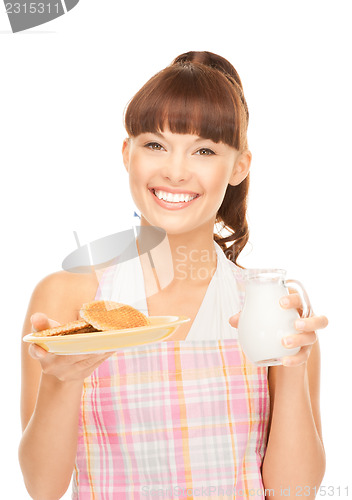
[0,0,352,499]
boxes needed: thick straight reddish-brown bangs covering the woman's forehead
[125,64,246,149]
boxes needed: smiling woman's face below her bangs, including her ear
[122,130,251,238]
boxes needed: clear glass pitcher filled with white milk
[238,269,311,366]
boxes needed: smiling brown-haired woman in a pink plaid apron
[20,52,326,500]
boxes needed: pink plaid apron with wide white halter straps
[72,242,269,500]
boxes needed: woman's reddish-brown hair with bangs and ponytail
[125,52,249,264]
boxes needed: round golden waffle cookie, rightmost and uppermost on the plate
[80,300,149,331]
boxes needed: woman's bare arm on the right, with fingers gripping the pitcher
[262,293,328,498]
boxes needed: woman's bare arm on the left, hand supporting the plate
[19,272,111,500]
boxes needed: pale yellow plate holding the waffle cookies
[23,316,190,354]
